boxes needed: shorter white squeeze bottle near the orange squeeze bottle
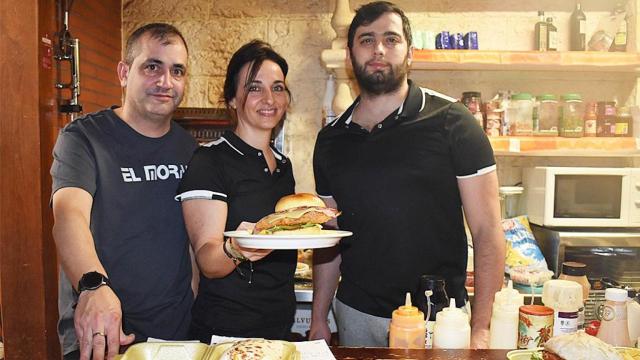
[433,299,471,349]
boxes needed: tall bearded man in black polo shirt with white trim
[310,2,505,348]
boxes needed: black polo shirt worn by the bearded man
[313,82,495,317]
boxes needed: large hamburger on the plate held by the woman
[253,193,340,235]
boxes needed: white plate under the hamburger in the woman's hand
[224,230,353,249]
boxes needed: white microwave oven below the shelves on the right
[522,166,640,227]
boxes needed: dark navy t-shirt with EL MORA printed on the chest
[51,110,196,353]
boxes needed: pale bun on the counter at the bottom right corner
[542,331,622,360]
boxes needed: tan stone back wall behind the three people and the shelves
[122,0,635,191]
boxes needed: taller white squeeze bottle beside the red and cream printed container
[489,280,524,349]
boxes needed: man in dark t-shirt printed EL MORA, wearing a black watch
[51,24,196,359]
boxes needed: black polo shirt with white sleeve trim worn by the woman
[176,131,297,336]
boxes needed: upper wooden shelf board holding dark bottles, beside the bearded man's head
[411,50,640,73]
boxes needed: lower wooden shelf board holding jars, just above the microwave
[489,136,640,157]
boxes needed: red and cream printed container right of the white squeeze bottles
[518,305,553,349]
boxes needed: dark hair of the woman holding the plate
[222,40,291,126]
